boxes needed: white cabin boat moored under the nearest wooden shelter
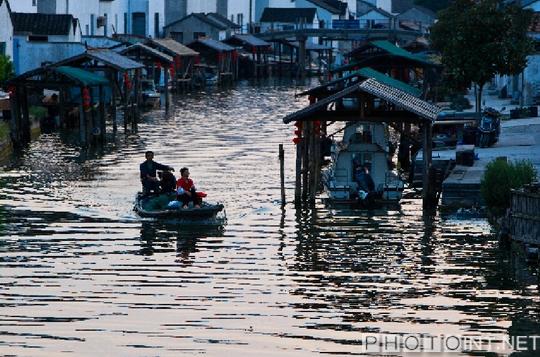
[322,122,404,207]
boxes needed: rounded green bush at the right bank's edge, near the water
[480,160,537,216]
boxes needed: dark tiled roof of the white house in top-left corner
[11,12,77,36]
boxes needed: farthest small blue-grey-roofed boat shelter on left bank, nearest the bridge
[223,34,272,77]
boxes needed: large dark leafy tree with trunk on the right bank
[431,0,533,111]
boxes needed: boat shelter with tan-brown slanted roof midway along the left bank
[145,38,199,86]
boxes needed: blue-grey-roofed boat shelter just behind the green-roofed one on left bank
[52,49,144,130]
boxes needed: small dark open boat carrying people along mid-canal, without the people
[133,192,225,221]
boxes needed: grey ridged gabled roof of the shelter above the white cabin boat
[283,78,441,124]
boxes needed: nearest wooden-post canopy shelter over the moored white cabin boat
[283,76,441,205]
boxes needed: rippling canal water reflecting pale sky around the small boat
[0,82,540,356]
